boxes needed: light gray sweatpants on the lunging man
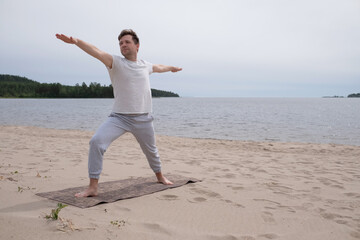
[88,113,161,179]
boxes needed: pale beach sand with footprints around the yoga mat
[0,126,360,240]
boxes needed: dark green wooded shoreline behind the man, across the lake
[0,74,179,98]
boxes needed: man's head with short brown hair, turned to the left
[118,29,140,61]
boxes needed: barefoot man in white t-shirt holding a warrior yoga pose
[56,29,182,197]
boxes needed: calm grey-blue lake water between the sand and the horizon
[0,98,360,146]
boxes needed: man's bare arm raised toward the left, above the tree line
[56,34,113,68]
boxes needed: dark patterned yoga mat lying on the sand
[36,175,199,208]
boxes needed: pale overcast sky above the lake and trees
[0,0,360,97]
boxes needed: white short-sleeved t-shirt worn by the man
[108,55,152,114]
